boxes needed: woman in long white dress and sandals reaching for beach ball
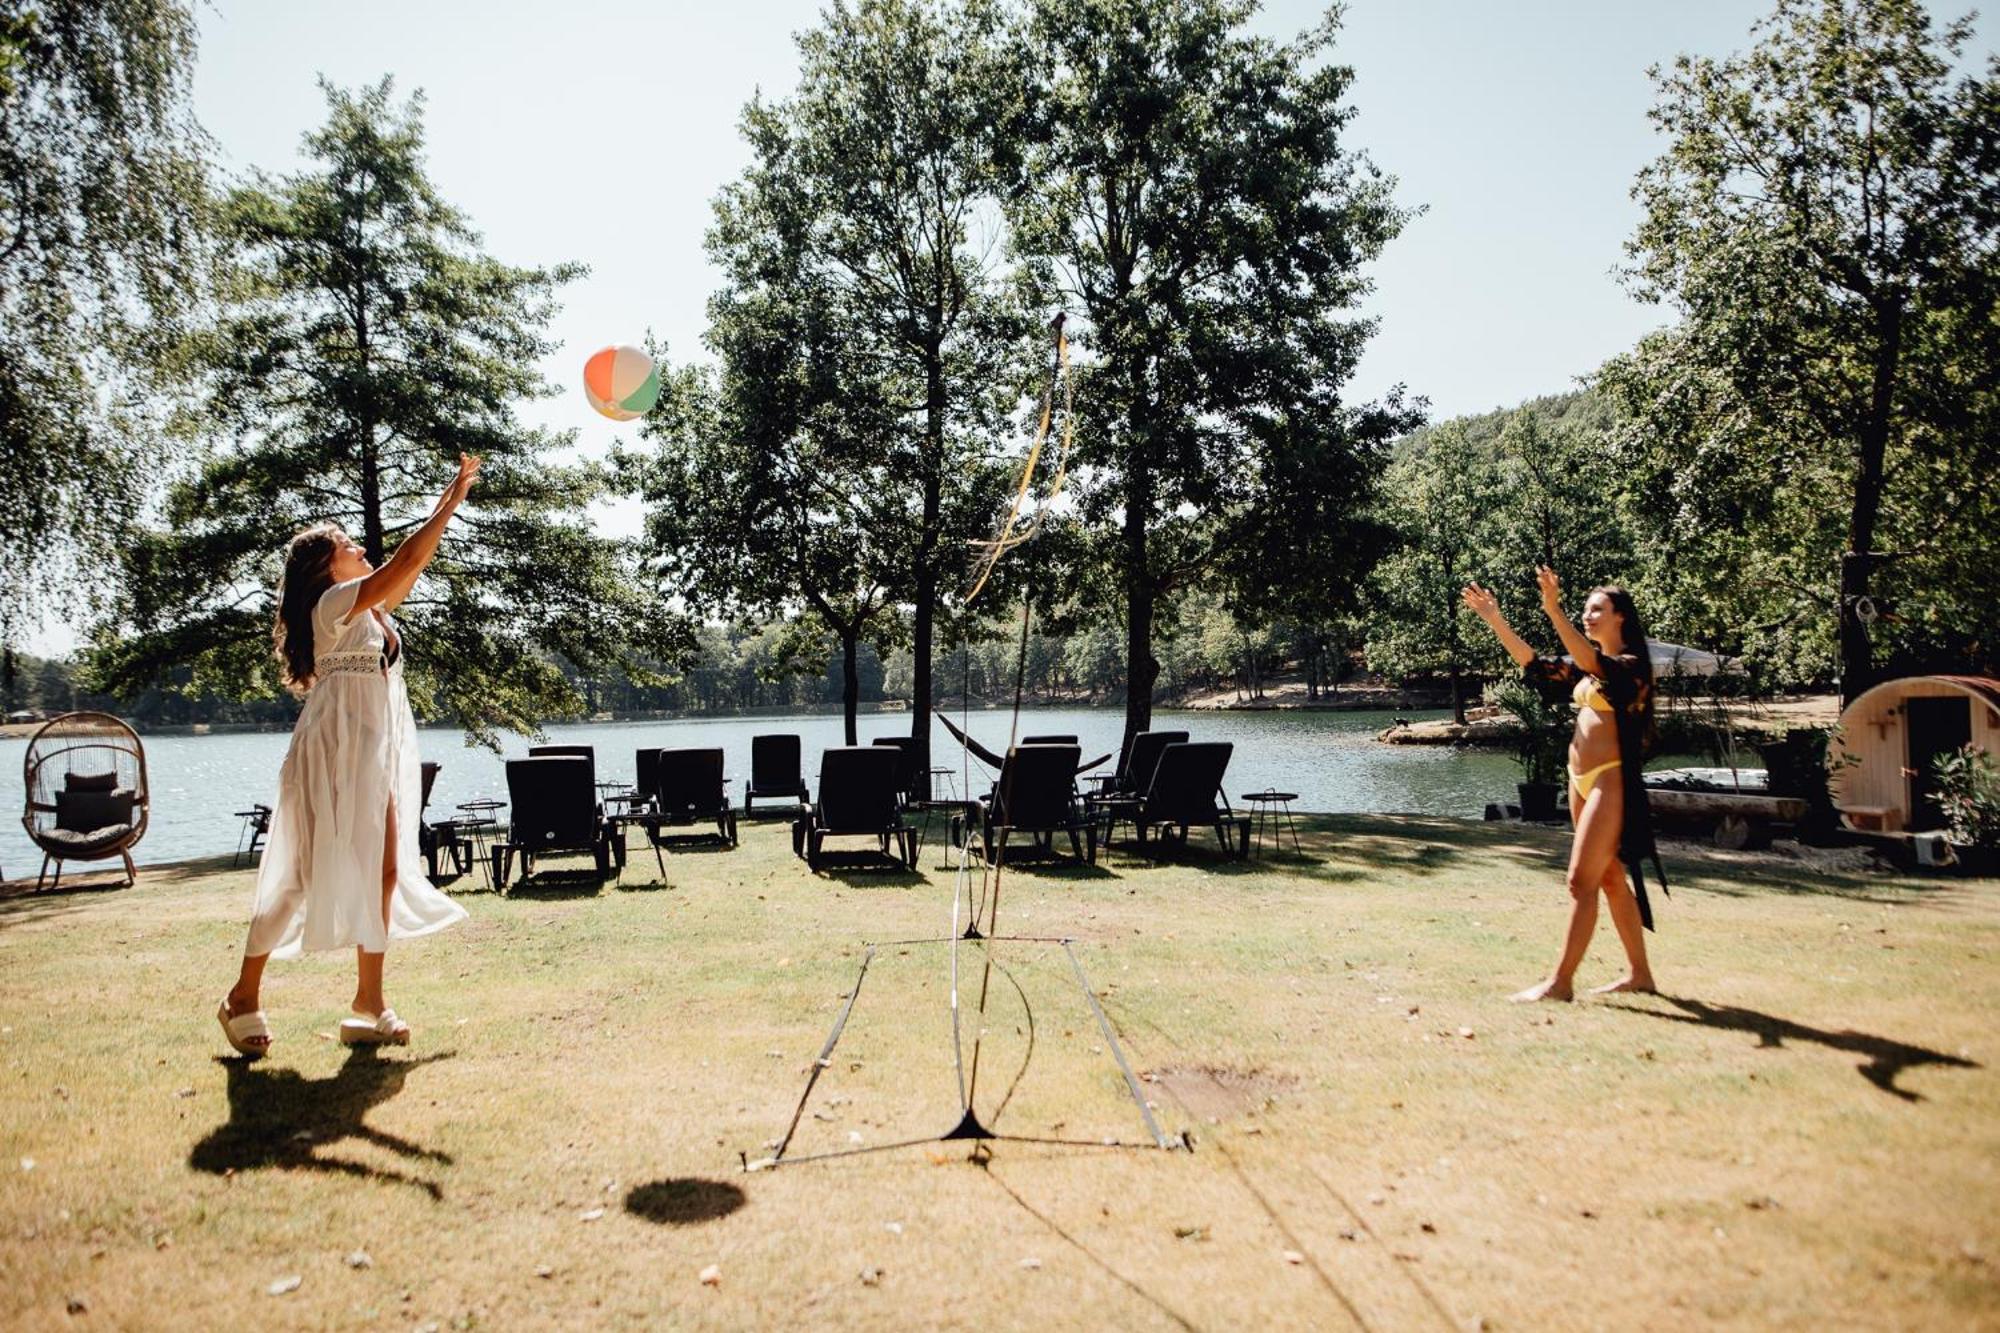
[216,454,480,1059]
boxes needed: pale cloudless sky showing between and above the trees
[23,0,1996,652]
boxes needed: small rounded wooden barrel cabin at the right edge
[1828,677,2000,833]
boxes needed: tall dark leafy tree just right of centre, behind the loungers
[1008,0,1412,737]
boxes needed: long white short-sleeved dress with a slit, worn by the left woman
[244,578,466,959]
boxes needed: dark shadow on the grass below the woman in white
[188,1047,454,1201]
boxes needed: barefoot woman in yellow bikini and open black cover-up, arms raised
[1464,568,1666,1001]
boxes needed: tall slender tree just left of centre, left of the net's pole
[772,0,1024,767]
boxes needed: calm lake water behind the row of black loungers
[0,709,1520,879]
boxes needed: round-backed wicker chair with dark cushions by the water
[20,713,152,889]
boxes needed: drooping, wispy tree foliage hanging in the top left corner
[0,0,208,640]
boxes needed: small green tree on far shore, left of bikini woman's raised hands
[1368,424,1498,723]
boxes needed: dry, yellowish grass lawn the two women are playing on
[0,817,2000,1329]
